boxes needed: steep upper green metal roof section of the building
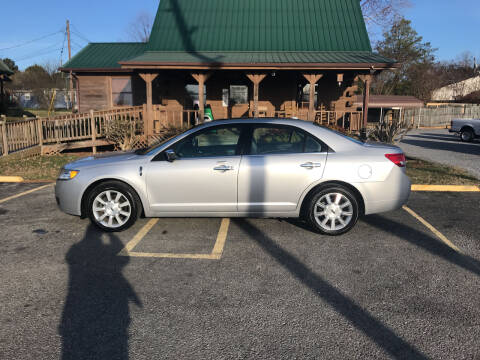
[147,0,372,51]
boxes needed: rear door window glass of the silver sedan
[251,127,305,155]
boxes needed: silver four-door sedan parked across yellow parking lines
[55,119,411,235]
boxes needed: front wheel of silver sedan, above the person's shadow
[87,181,141,232]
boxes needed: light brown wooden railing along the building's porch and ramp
[0,105,362,155]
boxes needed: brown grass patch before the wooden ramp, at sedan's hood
[0,153,88,181]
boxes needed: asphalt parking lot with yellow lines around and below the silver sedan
[0,184,480,359]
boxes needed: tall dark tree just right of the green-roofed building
[372,18,437,100]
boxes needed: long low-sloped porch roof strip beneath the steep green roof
[122,51,394,65]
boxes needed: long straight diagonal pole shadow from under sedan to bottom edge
[234,219,427,359]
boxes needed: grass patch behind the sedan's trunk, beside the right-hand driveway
[407,158,480,185]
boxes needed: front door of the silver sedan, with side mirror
[146,124,242,216]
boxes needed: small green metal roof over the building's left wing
[63,43,146,70]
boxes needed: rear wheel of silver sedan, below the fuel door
[305,185,359,236]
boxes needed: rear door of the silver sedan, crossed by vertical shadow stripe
[238,125,328,215]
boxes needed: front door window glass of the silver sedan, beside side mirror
[174,127,241,158]
